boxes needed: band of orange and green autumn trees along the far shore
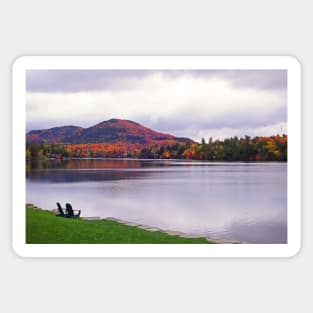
[26,135,288,161]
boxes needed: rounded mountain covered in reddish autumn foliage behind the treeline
[26,119,193,145]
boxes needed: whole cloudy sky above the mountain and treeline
[26,70,287,141]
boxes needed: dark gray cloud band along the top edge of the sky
[26,70,287,93]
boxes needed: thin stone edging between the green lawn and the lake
[26,203,244,244]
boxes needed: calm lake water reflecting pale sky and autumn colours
[26,159,287,243]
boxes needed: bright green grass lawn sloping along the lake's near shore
[26,207,213,244]
